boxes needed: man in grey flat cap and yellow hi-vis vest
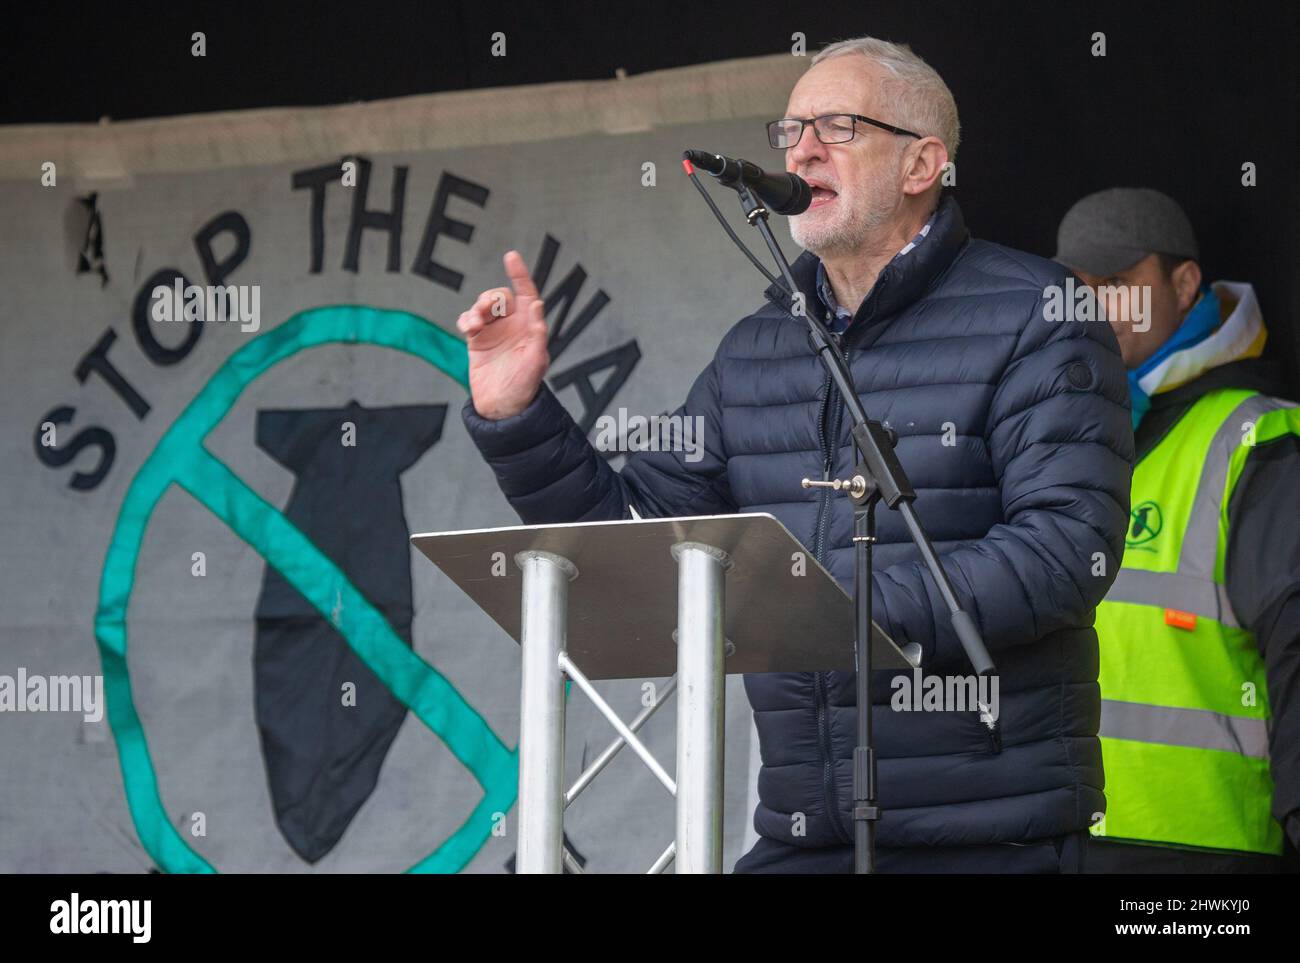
[1056,188,1300,872]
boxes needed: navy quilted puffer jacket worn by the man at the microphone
[464,198,1134,846]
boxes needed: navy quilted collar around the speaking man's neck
[764,195,970,331]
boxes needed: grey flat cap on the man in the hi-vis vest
[1052,187,1200,276]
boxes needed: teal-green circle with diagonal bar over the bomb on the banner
[95,305,517,872]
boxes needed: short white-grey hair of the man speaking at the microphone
[809,36,962,160]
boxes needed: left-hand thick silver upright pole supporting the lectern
[515,551,577,873]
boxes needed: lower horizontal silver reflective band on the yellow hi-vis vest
[1097,699,1269,759]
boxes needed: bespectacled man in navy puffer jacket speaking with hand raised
[458,38,1134,872]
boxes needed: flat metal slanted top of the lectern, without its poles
[411,513,911,678]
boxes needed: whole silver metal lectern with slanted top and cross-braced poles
[411,513,917,873]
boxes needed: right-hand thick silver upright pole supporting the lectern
[672,542,732,873]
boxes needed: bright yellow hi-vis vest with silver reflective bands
[1092,390,1300,854]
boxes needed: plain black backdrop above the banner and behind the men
[10,0,1300,396]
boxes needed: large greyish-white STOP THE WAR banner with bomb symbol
[0,57,803,872]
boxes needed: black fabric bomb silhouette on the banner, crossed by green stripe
[254,402,447,863]
